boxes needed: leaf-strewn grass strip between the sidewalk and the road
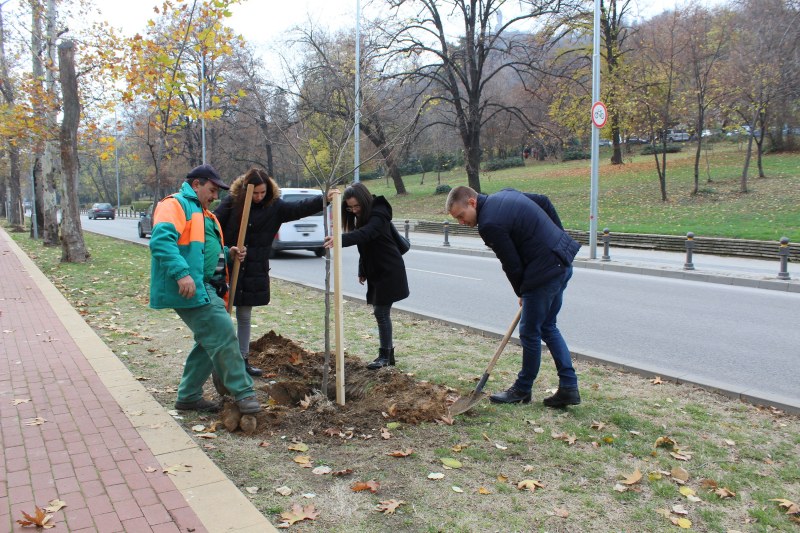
[7,233,800,532]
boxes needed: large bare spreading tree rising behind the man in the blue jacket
[386,0,571,191]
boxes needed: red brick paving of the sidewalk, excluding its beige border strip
[0,231,206,532]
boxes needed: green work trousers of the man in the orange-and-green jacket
[175,284,255,403]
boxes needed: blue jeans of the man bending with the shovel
[514,266,578,392]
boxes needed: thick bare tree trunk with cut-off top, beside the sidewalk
[58,41,89,263]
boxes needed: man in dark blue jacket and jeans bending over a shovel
[445,186,581,407]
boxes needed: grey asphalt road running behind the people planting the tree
[82,217,800,406]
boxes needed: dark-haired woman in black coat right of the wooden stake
[322,183,409,370]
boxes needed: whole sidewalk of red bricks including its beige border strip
[0,229,276,533]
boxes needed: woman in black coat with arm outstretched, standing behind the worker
[214,168,322,377]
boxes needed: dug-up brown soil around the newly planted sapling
[223,331,455,441]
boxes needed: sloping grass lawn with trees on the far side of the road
[376,142,800,242]
